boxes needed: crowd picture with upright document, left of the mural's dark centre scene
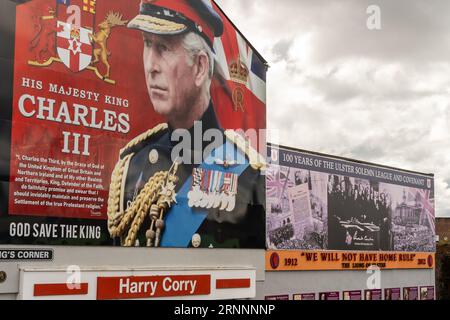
[267,166,328,250]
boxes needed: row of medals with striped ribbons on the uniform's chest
[188,168,238,212]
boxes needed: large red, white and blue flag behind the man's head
[204,0,267,153]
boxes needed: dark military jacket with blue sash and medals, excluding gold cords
[108,104,265,248]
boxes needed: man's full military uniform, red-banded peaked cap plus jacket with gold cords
[108,0,265,248]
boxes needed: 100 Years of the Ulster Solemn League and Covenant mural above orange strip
[267,147,435,252]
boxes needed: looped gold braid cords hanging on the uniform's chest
[108,160,178,247]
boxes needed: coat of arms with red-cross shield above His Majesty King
[28,0,128,84]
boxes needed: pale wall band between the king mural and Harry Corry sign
[0,245,265,299]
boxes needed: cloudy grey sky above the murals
[216,0,450,217]
